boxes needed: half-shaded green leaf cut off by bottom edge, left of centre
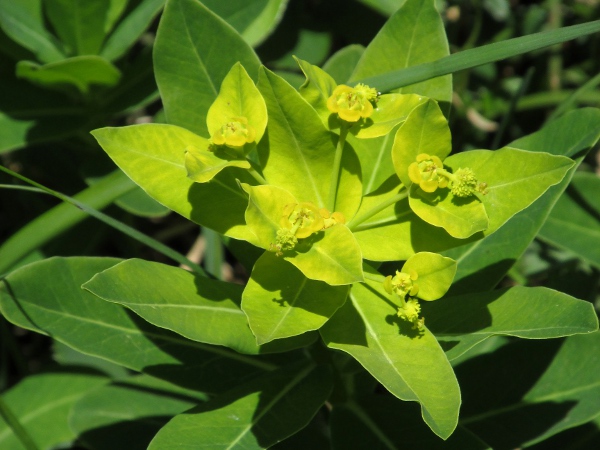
[148,366,332,450]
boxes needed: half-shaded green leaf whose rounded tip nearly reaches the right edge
[422,286,598,359]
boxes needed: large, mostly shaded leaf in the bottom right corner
[457,333,600,448]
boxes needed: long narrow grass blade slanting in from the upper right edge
[353,20,600,93]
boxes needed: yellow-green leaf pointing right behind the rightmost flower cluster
[444,147,574,234]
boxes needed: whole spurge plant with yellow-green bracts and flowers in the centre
[2,0,598,449]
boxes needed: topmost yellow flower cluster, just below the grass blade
[327,83,378,122]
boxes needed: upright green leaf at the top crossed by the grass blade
[351,0,452,104]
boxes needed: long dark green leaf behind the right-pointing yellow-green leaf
[445,108,600,294]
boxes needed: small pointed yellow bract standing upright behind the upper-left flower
[206,62,267,142]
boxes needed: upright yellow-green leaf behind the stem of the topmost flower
[258,69,362,218]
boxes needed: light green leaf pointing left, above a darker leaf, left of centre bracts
[83,259,314,354]
